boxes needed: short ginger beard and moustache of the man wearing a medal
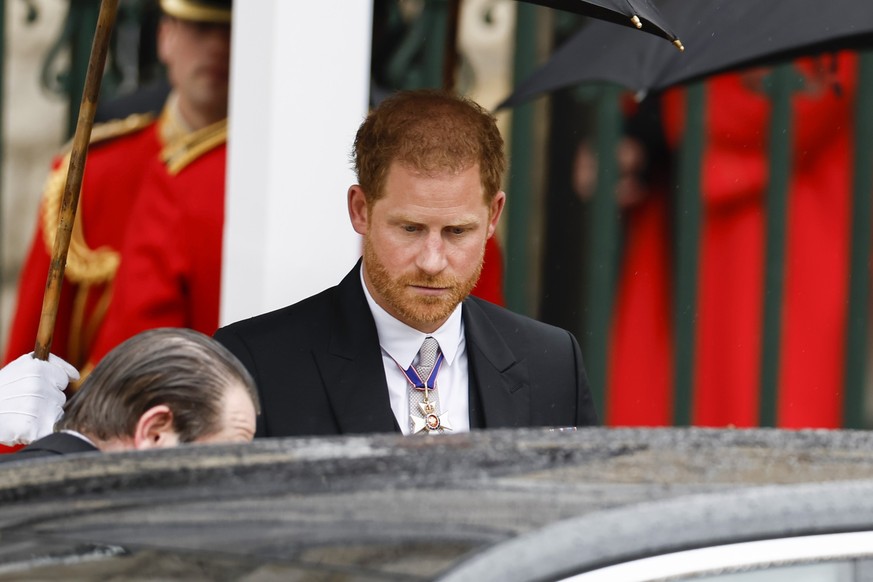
[364,237,485,327]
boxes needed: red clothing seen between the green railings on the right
[607,52,857,428]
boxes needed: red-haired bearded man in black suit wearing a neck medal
[215,91,596,436]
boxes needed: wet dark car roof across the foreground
[0,428,873,581]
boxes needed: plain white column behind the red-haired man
[221,0,372,324]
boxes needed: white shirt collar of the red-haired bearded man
[361,265,464,370]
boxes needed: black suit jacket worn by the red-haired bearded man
[215,261,597,436]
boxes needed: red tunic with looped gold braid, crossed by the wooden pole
[3,116,162,367]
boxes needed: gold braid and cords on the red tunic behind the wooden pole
[41,114,154,368]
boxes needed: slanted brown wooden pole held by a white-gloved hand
[33,0,118,360]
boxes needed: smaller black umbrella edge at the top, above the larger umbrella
[521,0,683,50]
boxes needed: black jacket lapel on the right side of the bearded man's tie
[464,298,531,428]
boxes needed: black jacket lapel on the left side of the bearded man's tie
[315,261,400,433]
